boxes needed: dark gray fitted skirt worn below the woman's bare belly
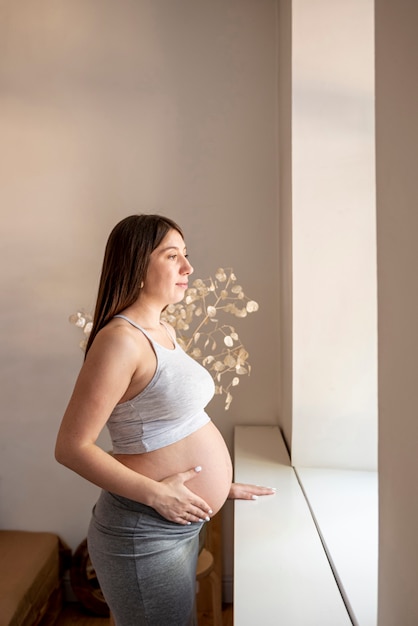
[87,491,202,626]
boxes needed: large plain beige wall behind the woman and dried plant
[0,0,279,588]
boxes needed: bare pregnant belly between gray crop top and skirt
[115,422,232,514]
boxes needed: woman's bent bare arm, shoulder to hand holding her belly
[55,327,210,524]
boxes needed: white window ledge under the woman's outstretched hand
[234,426,377,626]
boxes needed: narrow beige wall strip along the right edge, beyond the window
[376,0,418,626]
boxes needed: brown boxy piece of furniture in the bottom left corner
[0,530,71,626]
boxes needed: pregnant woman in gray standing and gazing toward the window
[55,215,274,626]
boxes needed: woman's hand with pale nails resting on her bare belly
[151,467,213,525]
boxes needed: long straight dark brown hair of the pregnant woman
[85,215,183,355]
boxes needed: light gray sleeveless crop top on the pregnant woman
[107,315,215,454]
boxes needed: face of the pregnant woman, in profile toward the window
[141,229,193,307]
